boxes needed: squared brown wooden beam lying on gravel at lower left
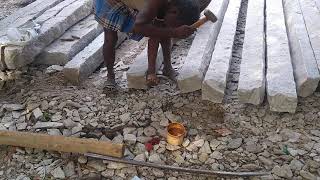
[0,131,124,158]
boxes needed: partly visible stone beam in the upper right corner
[299,0,320,89]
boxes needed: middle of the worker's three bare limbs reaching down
[147,38,159,86]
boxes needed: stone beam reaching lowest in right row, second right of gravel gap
[266,0,297,113]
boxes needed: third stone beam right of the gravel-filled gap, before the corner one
[283,0,320,97]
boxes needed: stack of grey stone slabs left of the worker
[0,0,125,84]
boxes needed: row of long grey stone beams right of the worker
[178,0,320,113]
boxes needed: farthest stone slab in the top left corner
[0,0,64,37]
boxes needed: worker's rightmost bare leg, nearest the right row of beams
[160,38,178,80]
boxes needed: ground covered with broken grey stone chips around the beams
[0,0,320,180]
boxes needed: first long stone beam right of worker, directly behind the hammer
[177,0,229,93]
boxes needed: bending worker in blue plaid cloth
[95,0,210,87]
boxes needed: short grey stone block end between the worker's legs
[127,43,172,89]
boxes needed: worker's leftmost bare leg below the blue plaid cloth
[103,29,118,86]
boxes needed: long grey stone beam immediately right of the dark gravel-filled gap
[238,0,266,105]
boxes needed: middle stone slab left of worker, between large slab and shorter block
[34,15,103,65]
